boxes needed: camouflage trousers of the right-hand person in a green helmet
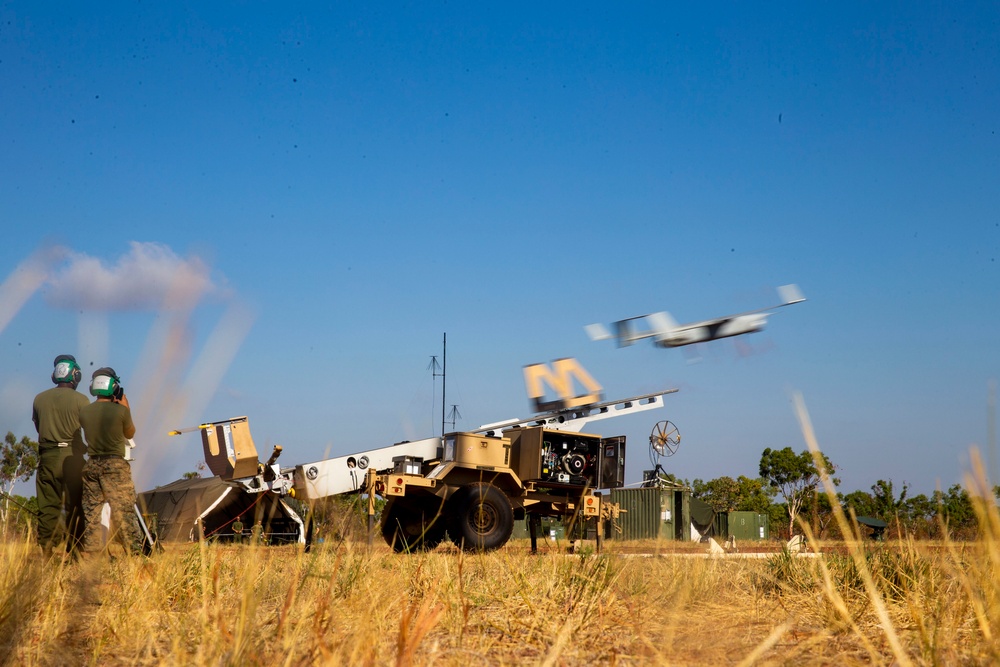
[83,456,142,554]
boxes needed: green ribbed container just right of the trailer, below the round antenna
[606,489,691,540]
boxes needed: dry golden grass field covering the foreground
[0,506,1000,665]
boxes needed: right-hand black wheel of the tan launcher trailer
[448,482,514,551]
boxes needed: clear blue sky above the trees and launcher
[0,2,1000,493]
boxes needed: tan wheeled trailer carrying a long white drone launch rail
[172,360,677,552]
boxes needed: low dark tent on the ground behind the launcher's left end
[139,477,305,544]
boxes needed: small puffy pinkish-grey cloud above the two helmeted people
[45,241,224,312]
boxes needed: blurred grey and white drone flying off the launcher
[584,285,806,347]
